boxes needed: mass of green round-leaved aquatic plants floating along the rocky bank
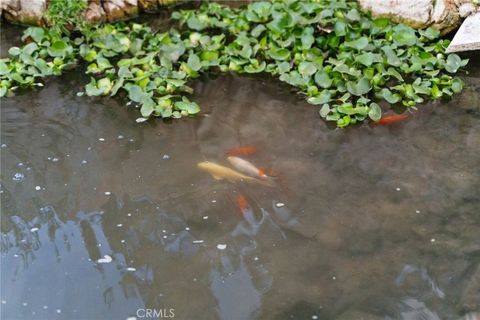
[0,0,468,127]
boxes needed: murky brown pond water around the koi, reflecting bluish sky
[0,26,480,320]
